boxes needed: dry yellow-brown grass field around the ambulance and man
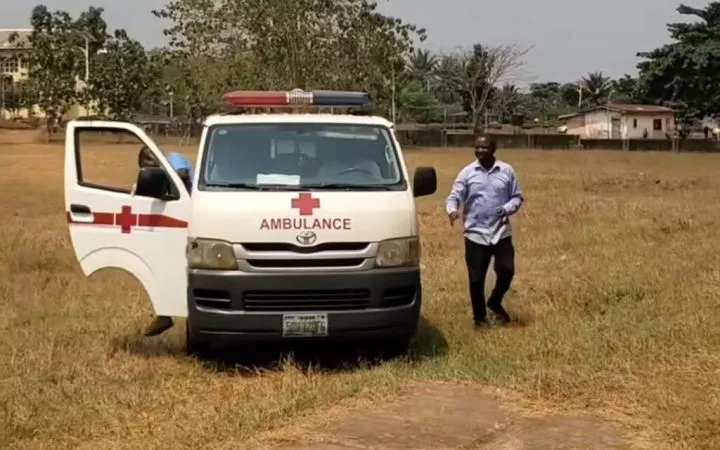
[0,129,720,449]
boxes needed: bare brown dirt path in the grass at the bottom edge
[275,385,638,450]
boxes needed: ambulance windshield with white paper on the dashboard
[199,123,404,190]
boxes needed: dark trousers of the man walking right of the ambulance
[465,237,515,321]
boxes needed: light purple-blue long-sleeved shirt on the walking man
[445,160,523,245]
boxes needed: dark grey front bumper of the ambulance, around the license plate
[188,268,422,341]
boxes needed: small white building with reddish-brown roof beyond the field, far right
[559,104,675,139]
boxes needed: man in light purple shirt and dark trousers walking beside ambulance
[445,136,523,327]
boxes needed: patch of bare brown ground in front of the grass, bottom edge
[258,383,660,450]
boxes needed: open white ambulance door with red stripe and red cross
[65,120,191,334]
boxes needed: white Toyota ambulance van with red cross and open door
[65,90,437,353]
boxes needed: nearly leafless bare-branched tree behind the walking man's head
[436,44,529,128]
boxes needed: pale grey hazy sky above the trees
[0,0,708,85]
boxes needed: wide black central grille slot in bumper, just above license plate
[243,289,370,311]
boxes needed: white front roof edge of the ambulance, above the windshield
[204,113,393,127]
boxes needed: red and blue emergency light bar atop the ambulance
[223,89,372,108]
